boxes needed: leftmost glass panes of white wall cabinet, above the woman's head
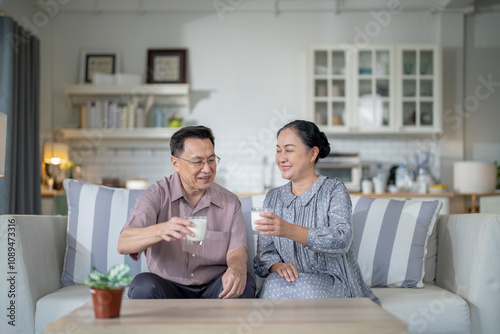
[312,48,349,128]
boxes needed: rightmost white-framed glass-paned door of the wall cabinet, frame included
[396,45,442,132]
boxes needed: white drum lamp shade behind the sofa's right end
[453,161,497,194]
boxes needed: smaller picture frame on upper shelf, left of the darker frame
[79,50,121,84]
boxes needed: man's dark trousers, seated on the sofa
[128,273,255,299]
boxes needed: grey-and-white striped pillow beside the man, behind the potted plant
[61,179,147,287]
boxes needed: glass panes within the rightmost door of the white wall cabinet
[398,46,437,130]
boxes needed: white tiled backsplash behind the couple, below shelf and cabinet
[72,130,440,193]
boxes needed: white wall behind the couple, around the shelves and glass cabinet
[41,6,446,192]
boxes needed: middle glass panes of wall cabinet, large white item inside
[354,48,394,131]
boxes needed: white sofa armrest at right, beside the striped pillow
[436,214,500,333]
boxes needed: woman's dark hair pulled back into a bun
[277,120,330,163]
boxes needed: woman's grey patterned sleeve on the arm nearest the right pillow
[306,182,352,255]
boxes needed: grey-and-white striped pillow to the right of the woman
[351,195,442,288]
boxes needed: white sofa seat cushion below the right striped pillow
[373,283,471,334]
